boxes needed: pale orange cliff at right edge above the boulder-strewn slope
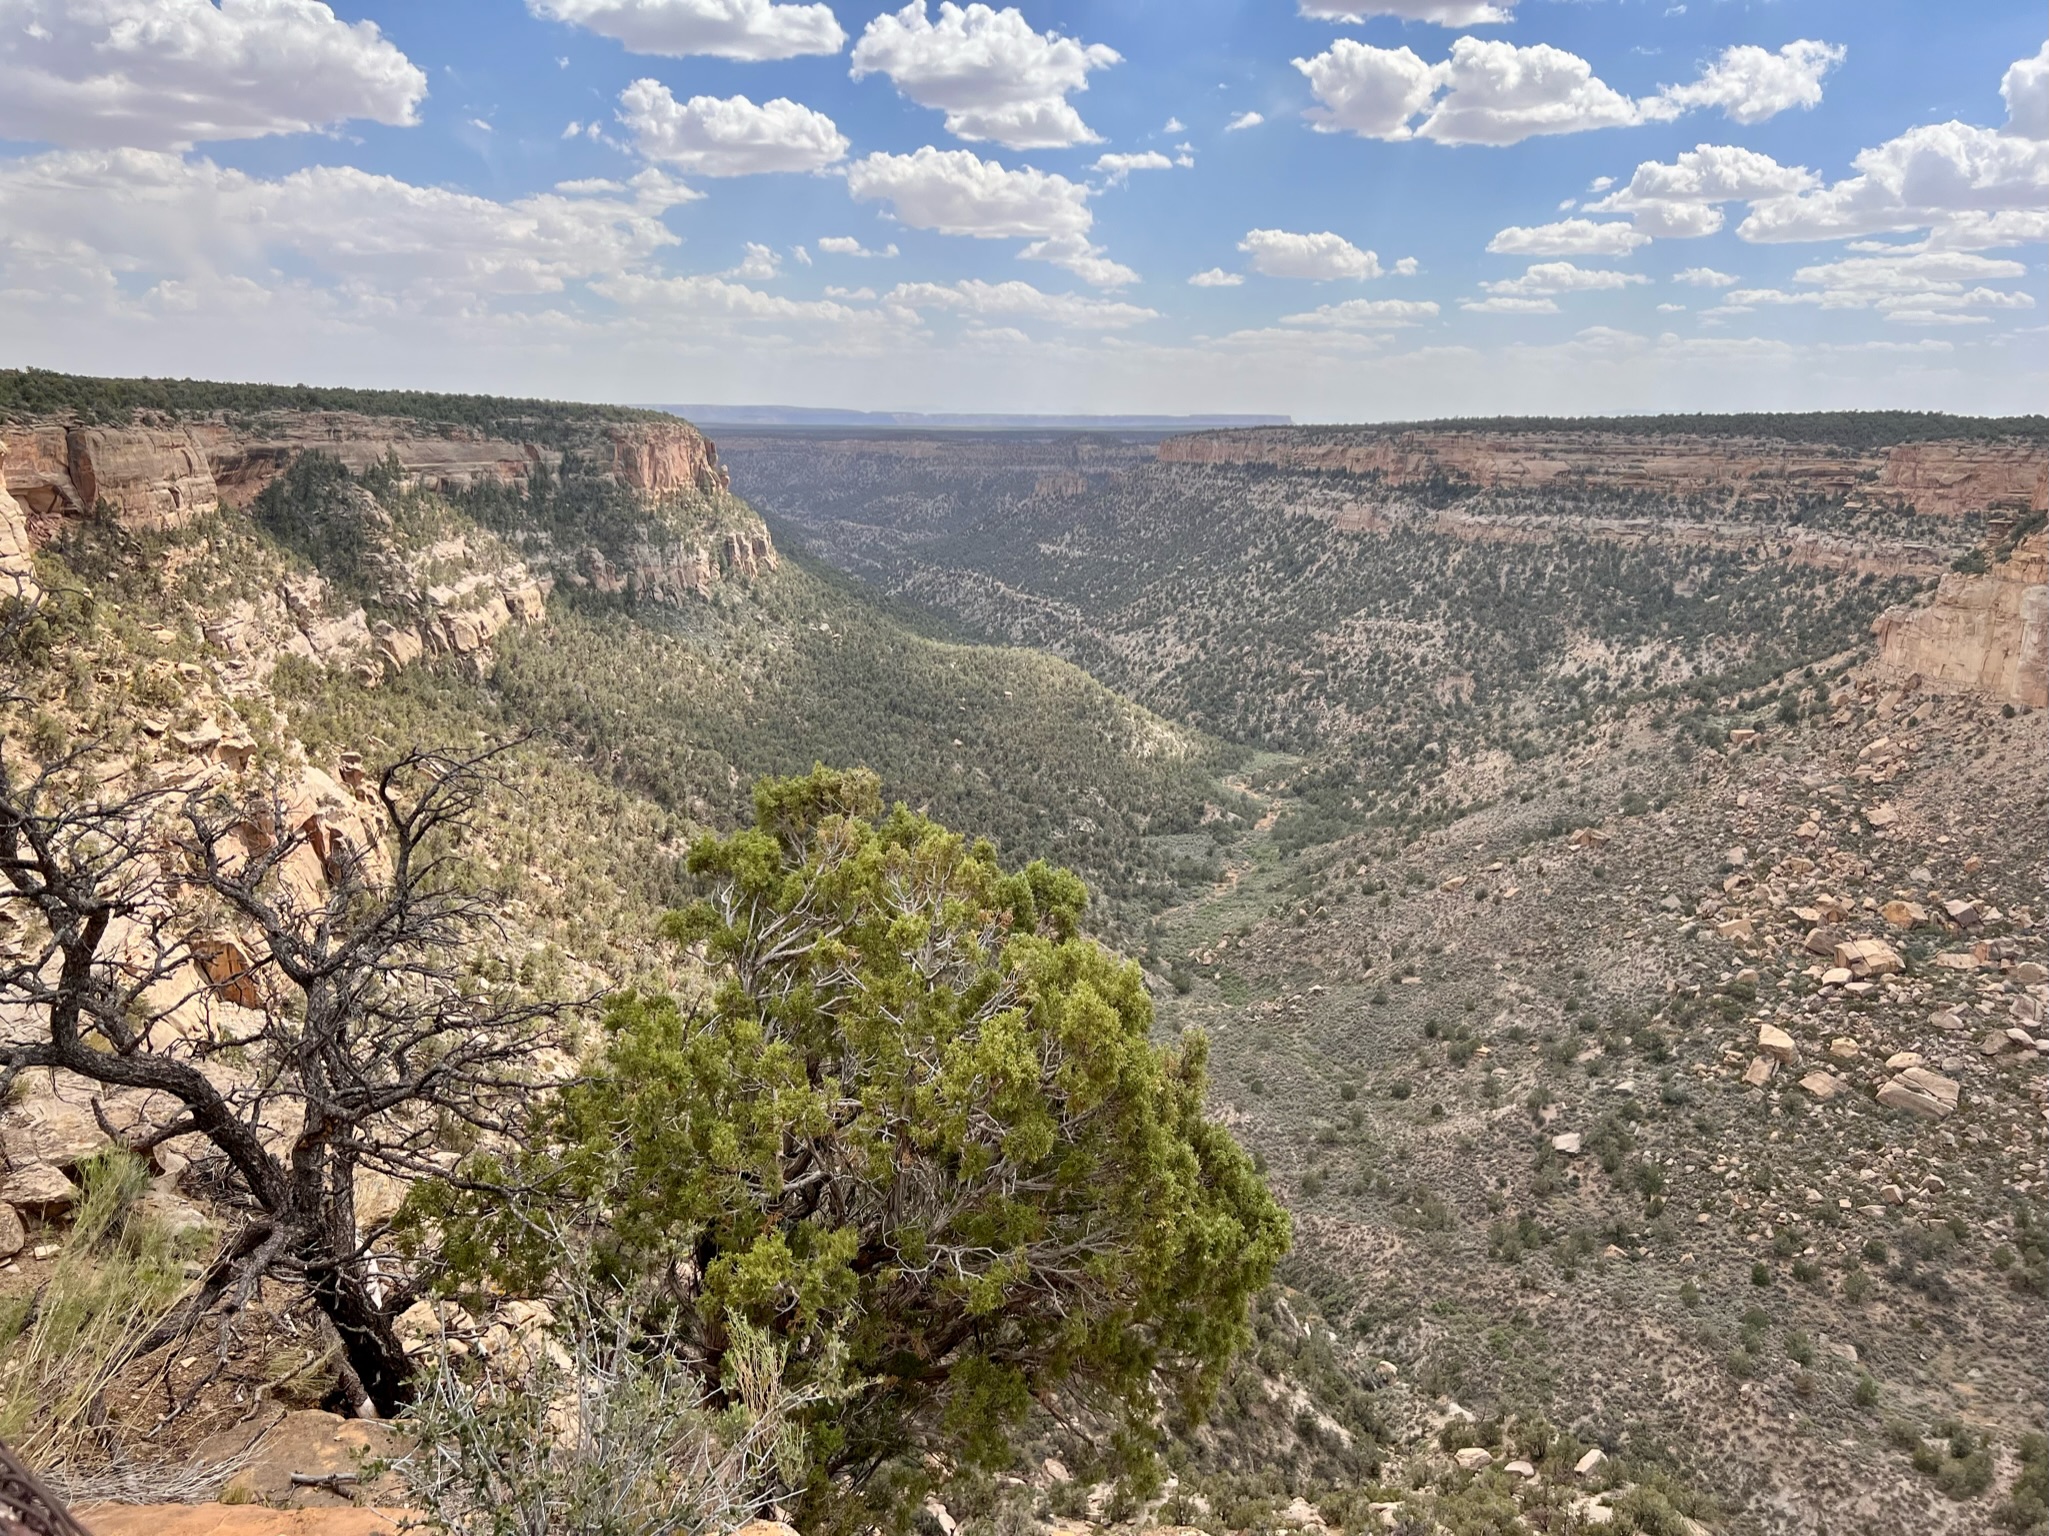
[1873,532,2049,709]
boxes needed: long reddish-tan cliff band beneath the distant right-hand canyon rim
[1160,428,2049,516]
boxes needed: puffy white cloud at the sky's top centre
[852,0,1121,150]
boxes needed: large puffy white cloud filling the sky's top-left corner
[0,0,426,150]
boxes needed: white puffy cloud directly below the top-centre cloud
[846,143,1094,240]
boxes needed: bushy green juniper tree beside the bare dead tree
[416,768,1289,1520]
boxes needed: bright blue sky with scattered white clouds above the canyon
[0,0,2049,420]
